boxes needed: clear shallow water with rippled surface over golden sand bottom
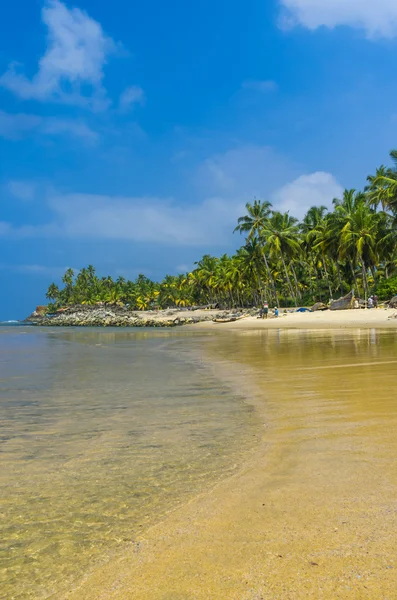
[0,327,258,600]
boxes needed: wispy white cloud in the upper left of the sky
[0,0,116,109]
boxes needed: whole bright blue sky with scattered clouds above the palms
[0,0,397,319]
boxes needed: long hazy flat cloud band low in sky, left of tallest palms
[0,194,244,246]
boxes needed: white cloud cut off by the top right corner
[280,0,397,38]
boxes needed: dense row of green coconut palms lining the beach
[47,150,397,310]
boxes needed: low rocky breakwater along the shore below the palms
[26,305,254,327]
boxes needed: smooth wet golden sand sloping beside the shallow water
[63,330,397,600]
